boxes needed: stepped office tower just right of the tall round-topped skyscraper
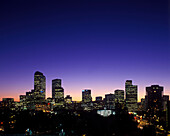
[52,79,64,106]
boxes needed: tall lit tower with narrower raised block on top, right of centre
[125,80,137,112]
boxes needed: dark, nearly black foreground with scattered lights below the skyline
[0,110,161,136]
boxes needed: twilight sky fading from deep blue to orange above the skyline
[0,0,170,101]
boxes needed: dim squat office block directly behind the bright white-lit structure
[105,94,115,109]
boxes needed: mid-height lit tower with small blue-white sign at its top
[82,89,92,103]
